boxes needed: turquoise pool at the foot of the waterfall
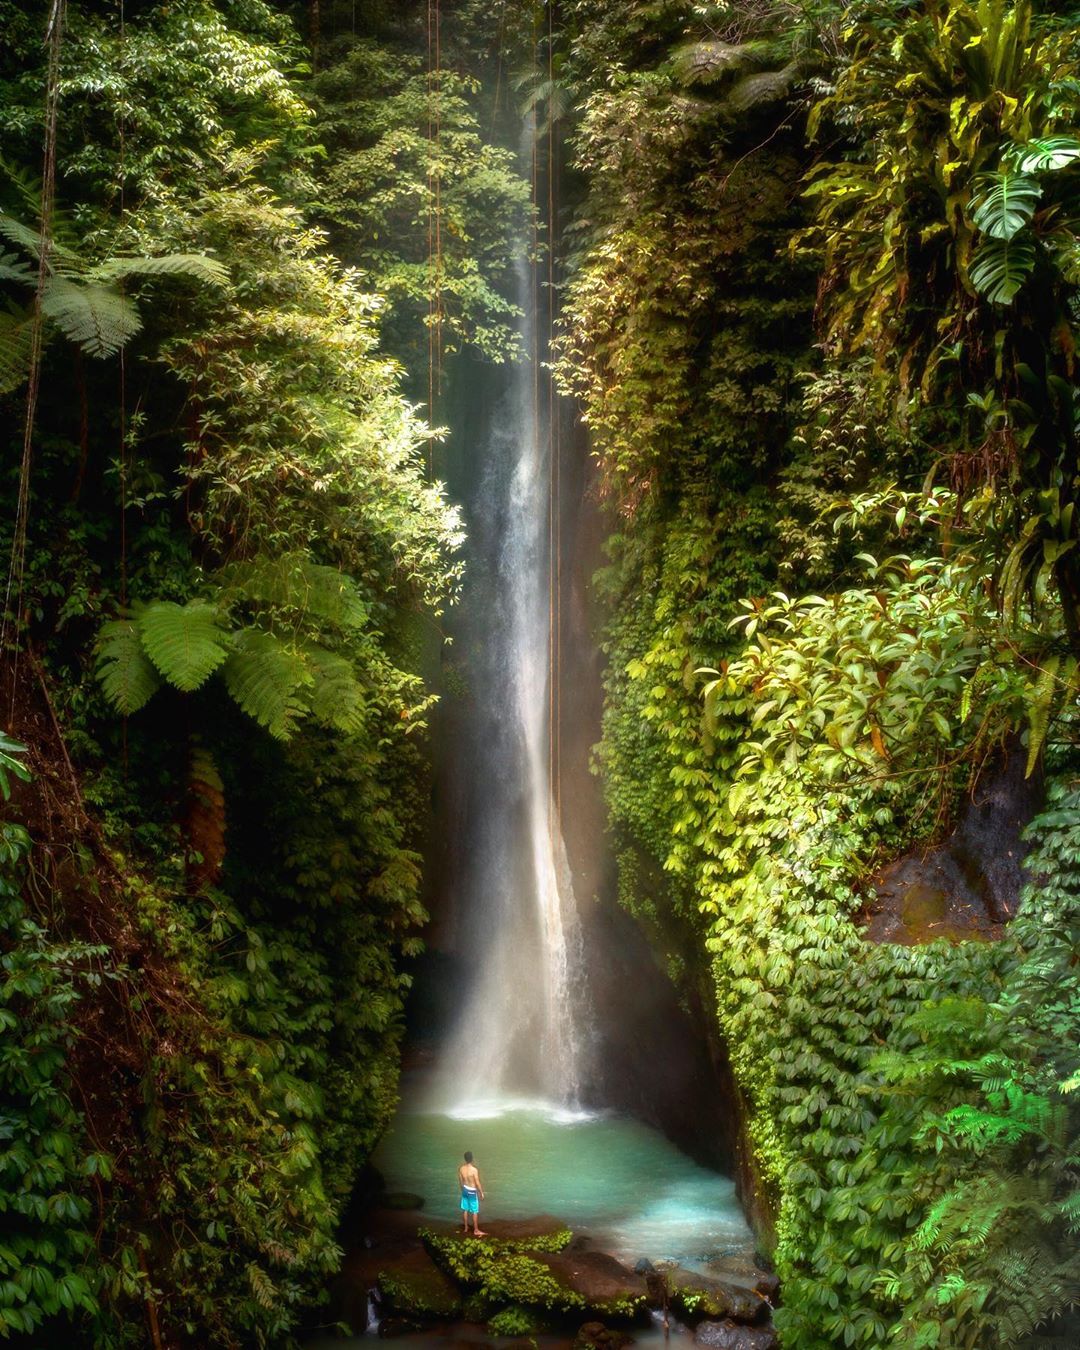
[373,1095,753,1265]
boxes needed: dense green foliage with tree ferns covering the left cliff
[0,0,507,1346]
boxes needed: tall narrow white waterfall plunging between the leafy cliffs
[434,126,589,1107]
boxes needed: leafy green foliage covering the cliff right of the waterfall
[562,0,1080,1350]
